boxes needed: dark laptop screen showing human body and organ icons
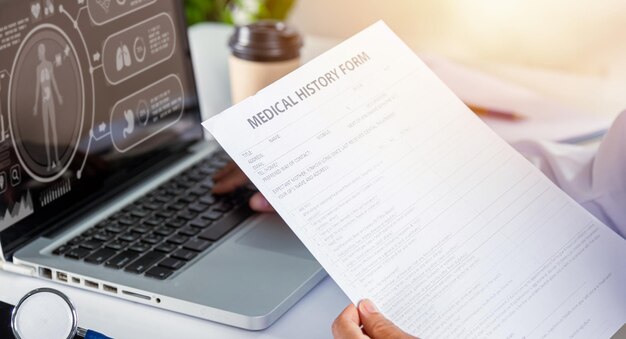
[0,0,202,253]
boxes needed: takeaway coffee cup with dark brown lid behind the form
[228,21,302,104]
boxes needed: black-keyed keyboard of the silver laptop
[52,153,253,280]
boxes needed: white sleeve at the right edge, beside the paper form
[513,111,626,238]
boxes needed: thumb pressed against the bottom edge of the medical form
[359,299,415,339]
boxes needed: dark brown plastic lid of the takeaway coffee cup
[228,20,302,61]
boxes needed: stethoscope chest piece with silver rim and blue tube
[11,288,110,339]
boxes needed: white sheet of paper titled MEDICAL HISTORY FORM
[204,22,626,338]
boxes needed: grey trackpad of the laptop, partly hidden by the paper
[236,213,315,260]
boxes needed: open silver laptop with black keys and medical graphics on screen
[0,0,325,330]
